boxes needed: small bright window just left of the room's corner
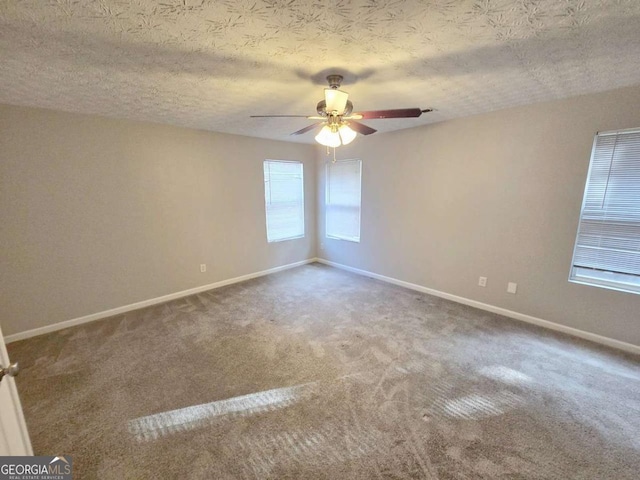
[264,160,304,242]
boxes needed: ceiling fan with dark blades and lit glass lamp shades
[251,75,433,148]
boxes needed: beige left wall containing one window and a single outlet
[0,106,316,335]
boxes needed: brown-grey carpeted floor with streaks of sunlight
[8,264,640,480]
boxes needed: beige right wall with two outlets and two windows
[318,87,640,345]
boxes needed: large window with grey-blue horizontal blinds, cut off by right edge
[569,129,640,293]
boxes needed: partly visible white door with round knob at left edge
[0,329,33,456]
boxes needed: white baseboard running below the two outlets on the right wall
[316,258,640,354]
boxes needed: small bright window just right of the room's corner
[325,160,362,242]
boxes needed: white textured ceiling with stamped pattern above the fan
[0,0,640,142]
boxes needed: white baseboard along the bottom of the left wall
[4,258,318,343]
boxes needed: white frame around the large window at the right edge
[569,128,640,295]
